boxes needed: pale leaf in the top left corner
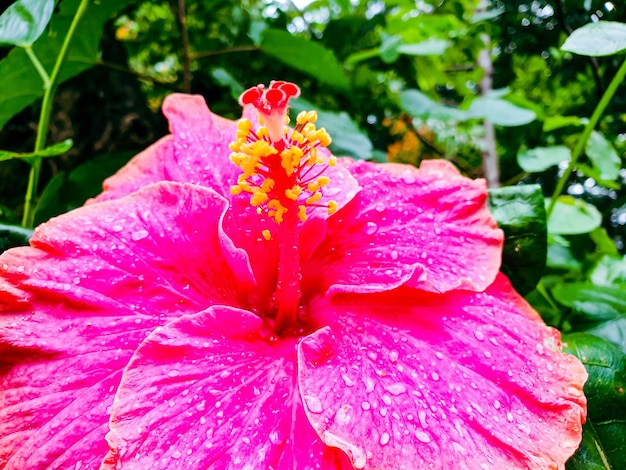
[0,0,54,47]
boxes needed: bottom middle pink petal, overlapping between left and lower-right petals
[104,306,351,469]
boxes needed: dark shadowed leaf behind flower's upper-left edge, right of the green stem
[35,151,135,224]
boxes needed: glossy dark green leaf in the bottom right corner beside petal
[563,333,626,470]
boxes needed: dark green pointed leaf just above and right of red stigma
[261,28,350,91]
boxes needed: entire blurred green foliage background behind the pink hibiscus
[0,0,626,469]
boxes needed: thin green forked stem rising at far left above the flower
[22,0,89,228]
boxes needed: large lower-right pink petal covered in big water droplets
[298,276,587,470]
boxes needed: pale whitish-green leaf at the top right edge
[561,21,626,57]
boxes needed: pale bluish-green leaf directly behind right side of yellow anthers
[290,98,373,159]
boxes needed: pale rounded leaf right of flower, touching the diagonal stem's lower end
[546,196,602,235]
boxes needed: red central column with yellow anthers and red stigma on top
[230,81,337,333]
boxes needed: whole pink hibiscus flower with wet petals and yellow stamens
[0,82,586,470]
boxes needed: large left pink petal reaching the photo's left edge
[0,183,253,470]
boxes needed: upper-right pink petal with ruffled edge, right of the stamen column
[303,160,503,292]
